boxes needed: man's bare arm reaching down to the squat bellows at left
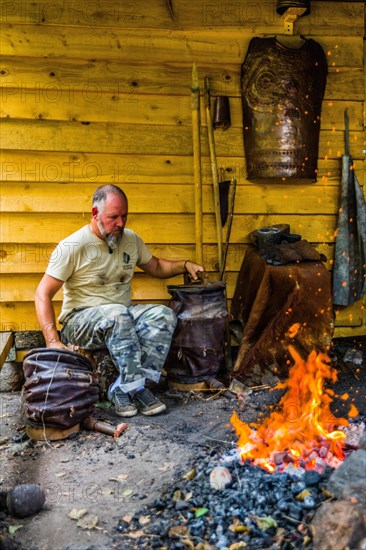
[34,274,68,349]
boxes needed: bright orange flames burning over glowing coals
[230,346,358,472]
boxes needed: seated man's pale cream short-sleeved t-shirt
[46,225,152,323]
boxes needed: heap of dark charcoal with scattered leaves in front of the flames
[115,451,333,550]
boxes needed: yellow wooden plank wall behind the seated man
[0,0,366,336]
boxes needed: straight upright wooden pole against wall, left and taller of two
[191,63,203,265]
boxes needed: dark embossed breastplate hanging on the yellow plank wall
[241,37,327,183]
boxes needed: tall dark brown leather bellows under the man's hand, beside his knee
[164,282,227,384]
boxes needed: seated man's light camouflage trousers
[62,304,177,392]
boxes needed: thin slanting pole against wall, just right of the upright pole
[204,76,222,273]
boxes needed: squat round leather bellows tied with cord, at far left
[22,348,99,429]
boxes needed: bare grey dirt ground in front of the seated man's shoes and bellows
[0,340,366,550]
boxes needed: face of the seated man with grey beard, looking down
[95,193,128,250]
